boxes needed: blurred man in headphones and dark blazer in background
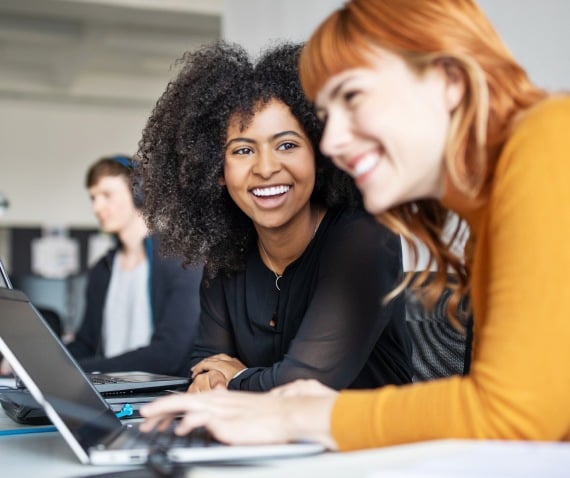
[68,155,202,376]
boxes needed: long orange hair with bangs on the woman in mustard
[300,0,546,325]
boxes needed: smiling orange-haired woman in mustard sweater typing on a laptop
[139,0,570,450]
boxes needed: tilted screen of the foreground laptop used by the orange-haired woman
[0,288,121,450]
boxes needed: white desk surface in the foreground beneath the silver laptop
[0,409,570,478]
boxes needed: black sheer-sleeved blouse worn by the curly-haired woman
[192,209,412,391]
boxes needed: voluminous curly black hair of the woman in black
[137,41,361,277]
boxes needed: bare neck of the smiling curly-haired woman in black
[256,205,325,275]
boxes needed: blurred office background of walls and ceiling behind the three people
[0,0,570,330]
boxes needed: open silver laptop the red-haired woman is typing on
[0,280,324,465]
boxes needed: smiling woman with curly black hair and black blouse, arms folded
[138,42,412,391]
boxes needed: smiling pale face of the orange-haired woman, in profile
[316,48,463,214]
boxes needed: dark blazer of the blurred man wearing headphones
[68,236,202,376]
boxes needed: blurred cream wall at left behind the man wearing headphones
[0,98,150,226]
